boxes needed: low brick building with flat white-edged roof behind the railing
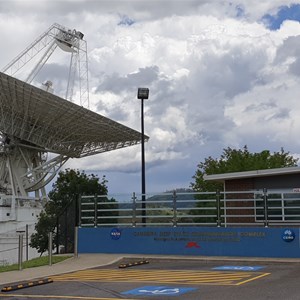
[204,167,300,225]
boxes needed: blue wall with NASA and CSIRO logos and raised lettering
[78,227,300,258]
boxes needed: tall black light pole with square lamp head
[137,88,149,224]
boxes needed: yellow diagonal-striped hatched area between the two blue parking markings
[52,269,270,285]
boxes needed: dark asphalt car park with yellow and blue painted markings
[0,258,300,300]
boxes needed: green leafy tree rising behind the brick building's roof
[191,145,298,192]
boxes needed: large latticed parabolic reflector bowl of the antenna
[0,72,148,158]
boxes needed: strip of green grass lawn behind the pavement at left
[0,255,72,273]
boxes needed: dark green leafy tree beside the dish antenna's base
[30,169,115,254]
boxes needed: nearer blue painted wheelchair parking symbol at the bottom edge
[121,286,196,296]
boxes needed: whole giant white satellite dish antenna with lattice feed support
[0,24,148,223]
